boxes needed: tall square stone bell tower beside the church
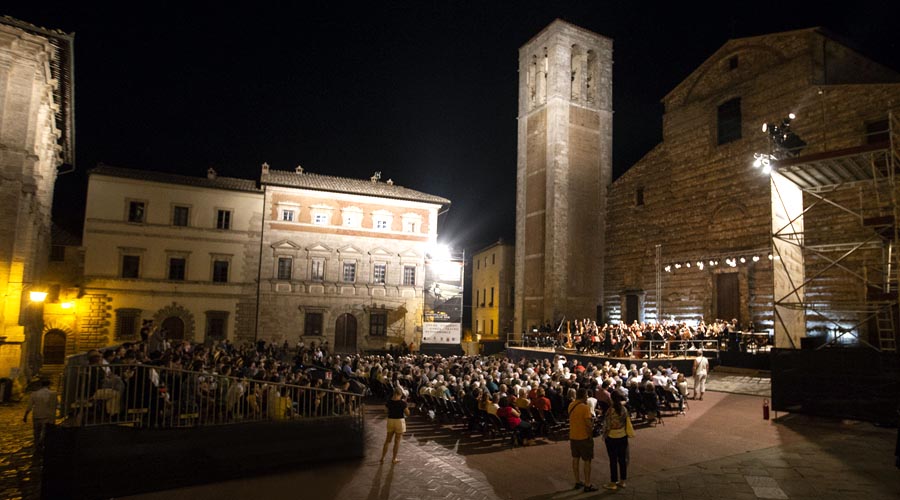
[515,19,613,332]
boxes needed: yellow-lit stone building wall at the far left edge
[0,18,74,377]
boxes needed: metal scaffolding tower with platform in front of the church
[772,110,900,352]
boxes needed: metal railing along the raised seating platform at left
[61,364,363,428]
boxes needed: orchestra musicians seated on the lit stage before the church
[523,319,741,359]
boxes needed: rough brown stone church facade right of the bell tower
[605,25,900,331]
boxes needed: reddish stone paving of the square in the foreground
[0,369,900,500]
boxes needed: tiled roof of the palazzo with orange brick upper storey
[260,170,450,205]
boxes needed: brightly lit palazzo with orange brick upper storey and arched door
[258,165,450,352]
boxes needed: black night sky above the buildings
[7,0,900,253]
